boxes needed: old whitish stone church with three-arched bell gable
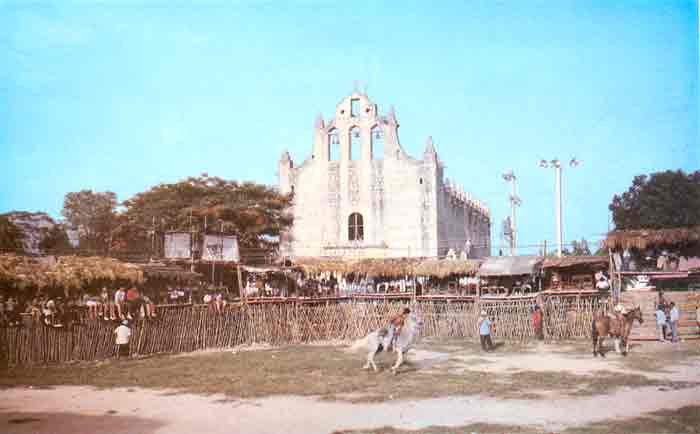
[278,89,491,258]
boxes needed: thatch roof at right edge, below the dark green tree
[603,226,700,250]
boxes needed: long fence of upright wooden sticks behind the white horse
[0,296,608,365]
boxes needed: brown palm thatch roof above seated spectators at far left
[0,253,143,289]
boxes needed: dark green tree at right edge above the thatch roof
[608,170,700,229]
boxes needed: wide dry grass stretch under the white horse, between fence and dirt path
[0,341,686,402]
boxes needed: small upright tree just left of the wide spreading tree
[61,190,117,251]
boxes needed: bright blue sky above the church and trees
[0,0,700,254]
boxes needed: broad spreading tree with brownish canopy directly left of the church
[116,175,291,247]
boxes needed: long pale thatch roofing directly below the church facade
[294,258,480,278]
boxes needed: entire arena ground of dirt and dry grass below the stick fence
[0,340,700,434]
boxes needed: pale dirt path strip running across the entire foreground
[5,387,700,434]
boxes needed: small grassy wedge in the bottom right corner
[564,405,700,434]
